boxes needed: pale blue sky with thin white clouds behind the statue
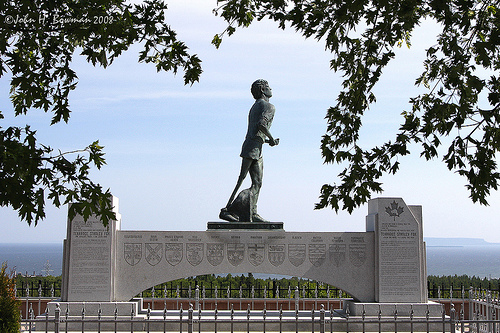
[0,0,500,243]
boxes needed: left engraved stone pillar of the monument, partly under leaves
[61,197,121,302]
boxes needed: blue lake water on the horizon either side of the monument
[0,243,500,279]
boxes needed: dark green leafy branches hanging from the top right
[213,0,500,212]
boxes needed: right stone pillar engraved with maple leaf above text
[366,198,427,303]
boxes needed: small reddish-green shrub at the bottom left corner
[0,263,21,333]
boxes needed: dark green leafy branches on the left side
[0,0,201,225]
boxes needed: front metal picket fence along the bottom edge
[20,306,500,333]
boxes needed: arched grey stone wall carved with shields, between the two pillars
[114,230,375,301]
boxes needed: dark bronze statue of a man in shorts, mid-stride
[219,79,279,222]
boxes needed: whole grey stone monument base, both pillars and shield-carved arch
[62,198,427,304]
